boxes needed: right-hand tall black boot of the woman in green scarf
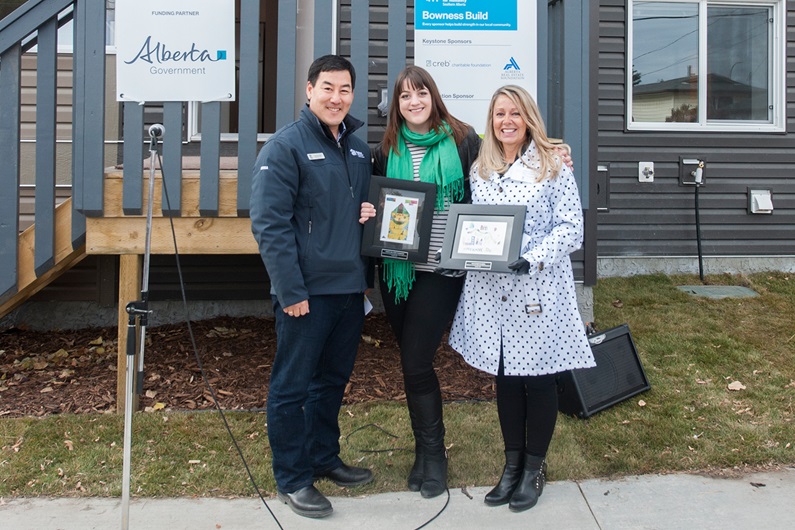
[406,389,447,499]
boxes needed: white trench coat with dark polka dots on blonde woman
[450,142,595,375]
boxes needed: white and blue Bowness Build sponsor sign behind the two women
[414,0,546,134]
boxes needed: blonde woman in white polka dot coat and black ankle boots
[450,85,595,511]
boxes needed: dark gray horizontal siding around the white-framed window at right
[597,0,795,256]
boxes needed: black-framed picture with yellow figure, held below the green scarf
[362,176,436,262]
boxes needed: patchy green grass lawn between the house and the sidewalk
[0,273,795,497]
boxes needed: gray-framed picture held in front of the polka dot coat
[439,204,525,272]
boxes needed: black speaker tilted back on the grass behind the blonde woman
[558,324,650,418]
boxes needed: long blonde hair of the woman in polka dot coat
[474,85,571,182]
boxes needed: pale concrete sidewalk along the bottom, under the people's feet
[0,467,795,530]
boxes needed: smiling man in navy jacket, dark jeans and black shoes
[251,55,373,517]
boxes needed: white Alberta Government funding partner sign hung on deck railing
[116,0,235,102]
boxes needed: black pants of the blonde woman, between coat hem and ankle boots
[497,359,558,457]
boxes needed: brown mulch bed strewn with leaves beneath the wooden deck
[0,314,494,418]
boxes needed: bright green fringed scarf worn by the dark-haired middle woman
[384,123,464,303]
